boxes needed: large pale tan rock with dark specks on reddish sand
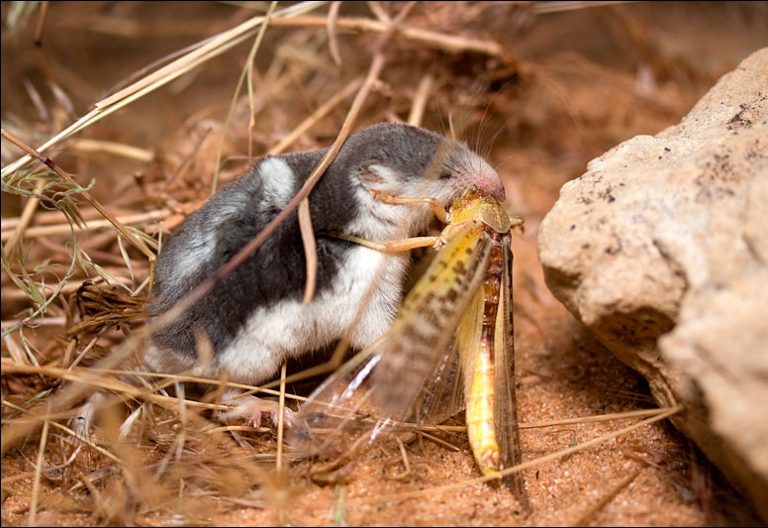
[539,48,768,521]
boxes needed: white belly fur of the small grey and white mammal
[213,246,408,384]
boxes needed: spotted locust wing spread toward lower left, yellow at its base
[289,223,490,455]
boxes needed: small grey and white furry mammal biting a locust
[145,124,504,408]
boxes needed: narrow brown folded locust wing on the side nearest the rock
[494,235,530,511]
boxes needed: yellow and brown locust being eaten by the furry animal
[289,187,528,509]
